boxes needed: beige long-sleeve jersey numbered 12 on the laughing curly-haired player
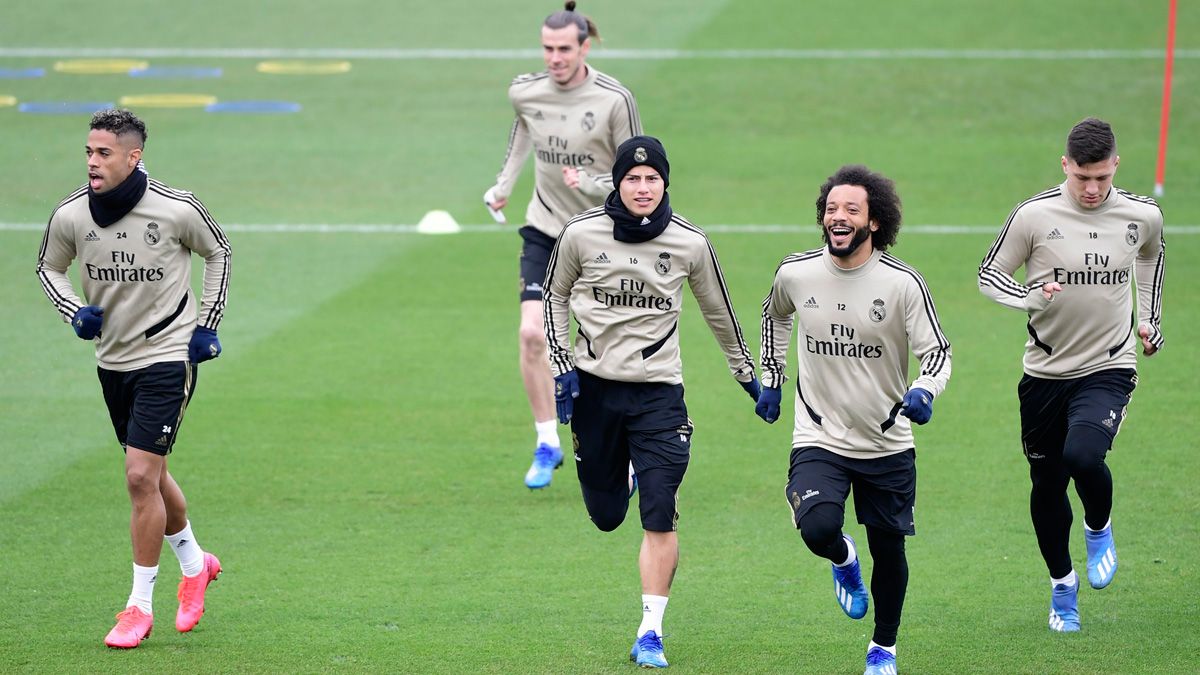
[762,249,950,459]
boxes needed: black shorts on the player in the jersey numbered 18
[1016,368,1138,461]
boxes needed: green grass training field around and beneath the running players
[0,0,1200,673]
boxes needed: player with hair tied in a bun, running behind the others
[484,1,642,489]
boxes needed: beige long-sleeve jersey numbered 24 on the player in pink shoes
[37,179,230,371]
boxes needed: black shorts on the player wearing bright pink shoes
[96,362,197,455]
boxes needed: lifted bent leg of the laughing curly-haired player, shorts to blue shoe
[785,448,870,619]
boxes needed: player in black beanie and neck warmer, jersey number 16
[545,136,758,668]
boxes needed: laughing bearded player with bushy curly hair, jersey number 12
[755,166,950,675]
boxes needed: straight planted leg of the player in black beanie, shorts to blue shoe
[624,383,695,668]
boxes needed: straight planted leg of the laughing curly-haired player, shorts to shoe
[848,449,917,674]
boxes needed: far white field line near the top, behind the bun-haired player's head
[0,47,1200,61]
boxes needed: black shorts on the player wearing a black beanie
[571,370,694,532]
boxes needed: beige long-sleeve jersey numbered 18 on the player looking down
[979,184,1165,380]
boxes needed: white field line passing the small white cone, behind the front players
[0,222,1200,235]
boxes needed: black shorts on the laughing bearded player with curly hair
[786,447,917,536]
